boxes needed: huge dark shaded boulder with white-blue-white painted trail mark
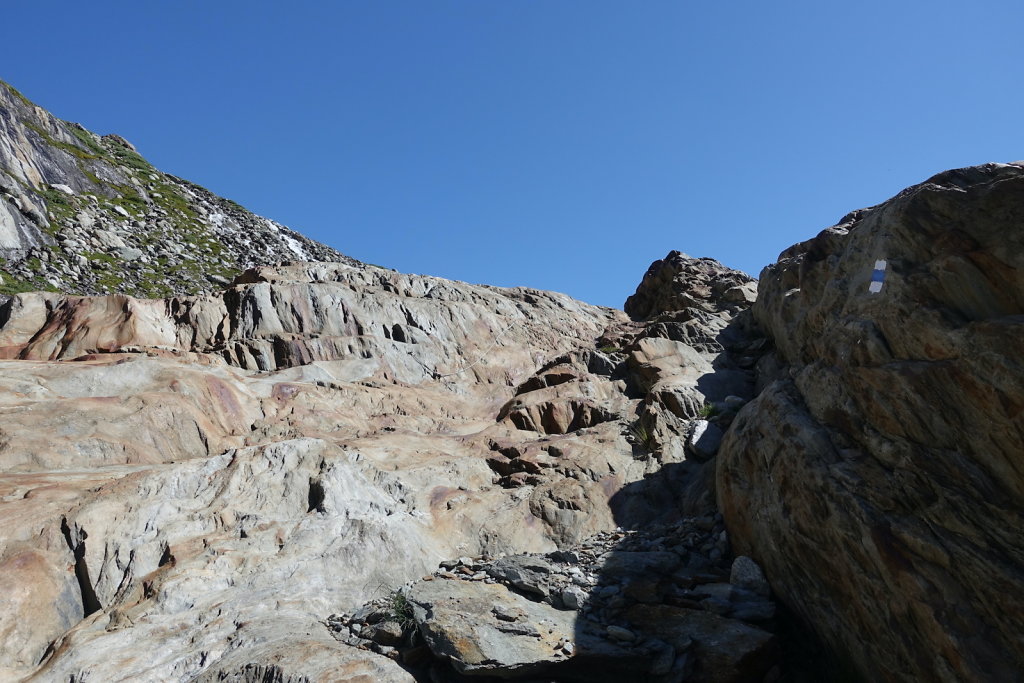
[718,164,1024,681]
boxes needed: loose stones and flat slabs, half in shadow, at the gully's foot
[327,516,780,682]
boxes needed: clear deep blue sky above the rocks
[0,0,1024,306]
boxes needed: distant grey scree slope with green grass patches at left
[0,81,352,297]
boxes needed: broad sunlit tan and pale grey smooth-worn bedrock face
[0,252,774,681]
